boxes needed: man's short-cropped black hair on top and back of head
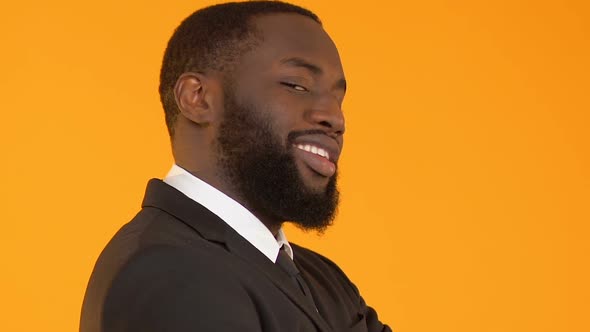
[159,1,322,137]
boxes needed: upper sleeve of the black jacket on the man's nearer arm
[101,246,261,332]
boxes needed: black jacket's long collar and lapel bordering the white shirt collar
[142,179,332,332]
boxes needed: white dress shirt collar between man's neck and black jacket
[164,164,293,263]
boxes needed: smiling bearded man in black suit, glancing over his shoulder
[80,1,391,332]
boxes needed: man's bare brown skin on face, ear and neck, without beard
[172,14,346,235]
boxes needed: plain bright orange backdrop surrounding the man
[0,0,590,332]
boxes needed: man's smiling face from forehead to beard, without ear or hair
[218,14,345,230]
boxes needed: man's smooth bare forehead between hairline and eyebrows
[240,14,344,76]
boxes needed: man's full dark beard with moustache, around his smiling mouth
[217,88,339,233]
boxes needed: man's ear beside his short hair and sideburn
[174,72,213,126]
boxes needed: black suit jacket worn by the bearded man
[80,179,391,332]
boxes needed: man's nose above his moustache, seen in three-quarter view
[308,95,345,136]
